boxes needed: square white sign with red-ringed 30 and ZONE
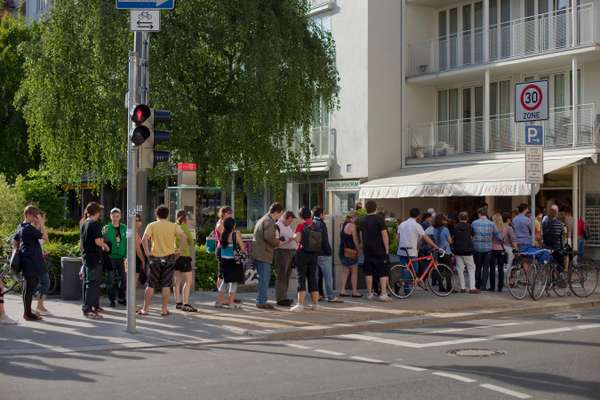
[515,80,549,122]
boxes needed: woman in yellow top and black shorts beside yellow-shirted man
[173,210,198,312]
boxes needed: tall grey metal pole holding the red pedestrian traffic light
[127,32,142,333]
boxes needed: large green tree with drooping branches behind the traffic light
[19,0,338,183]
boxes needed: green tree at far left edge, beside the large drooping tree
[0,16,39,182]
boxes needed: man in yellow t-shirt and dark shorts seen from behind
[138,204,187,317]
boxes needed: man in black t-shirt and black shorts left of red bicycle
[360,200,390,302]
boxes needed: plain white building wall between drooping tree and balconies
[286,0,402,215]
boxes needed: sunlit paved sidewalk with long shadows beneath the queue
[0,291,600,356]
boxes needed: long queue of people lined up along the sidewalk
[0,200,587,324]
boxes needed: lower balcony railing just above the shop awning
[408,104,600,158]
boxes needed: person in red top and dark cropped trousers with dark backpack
[291,207,323,312]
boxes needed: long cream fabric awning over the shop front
[359,154,592,199]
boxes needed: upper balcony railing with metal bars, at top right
[407,3,600,78]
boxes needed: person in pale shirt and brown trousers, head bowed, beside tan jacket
[273,211,298,307]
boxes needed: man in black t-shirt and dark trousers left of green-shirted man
[80,202,110,319]
